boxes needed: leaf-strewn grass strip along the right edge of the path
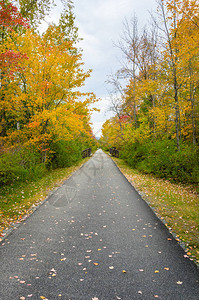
[114,158,199,264]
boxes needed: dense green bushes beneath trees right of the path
[122,140,199,183]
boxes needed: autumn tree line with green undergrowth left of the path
[0,0,96,184]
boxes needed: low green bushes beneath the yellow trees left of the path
[0,137,96,186]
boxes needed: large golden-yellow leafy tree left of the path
[1,0,96,162]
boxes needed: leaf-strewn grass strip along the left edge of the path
[0,158,89,241]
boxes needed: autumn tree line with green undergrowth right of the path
[101,0,199,183]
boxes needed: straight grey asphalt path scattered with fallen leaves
[0,150,199,300]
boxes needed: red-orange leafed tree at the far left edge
[0,1,28,137]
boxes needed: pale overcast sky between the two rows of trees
[47,0,156,136]
